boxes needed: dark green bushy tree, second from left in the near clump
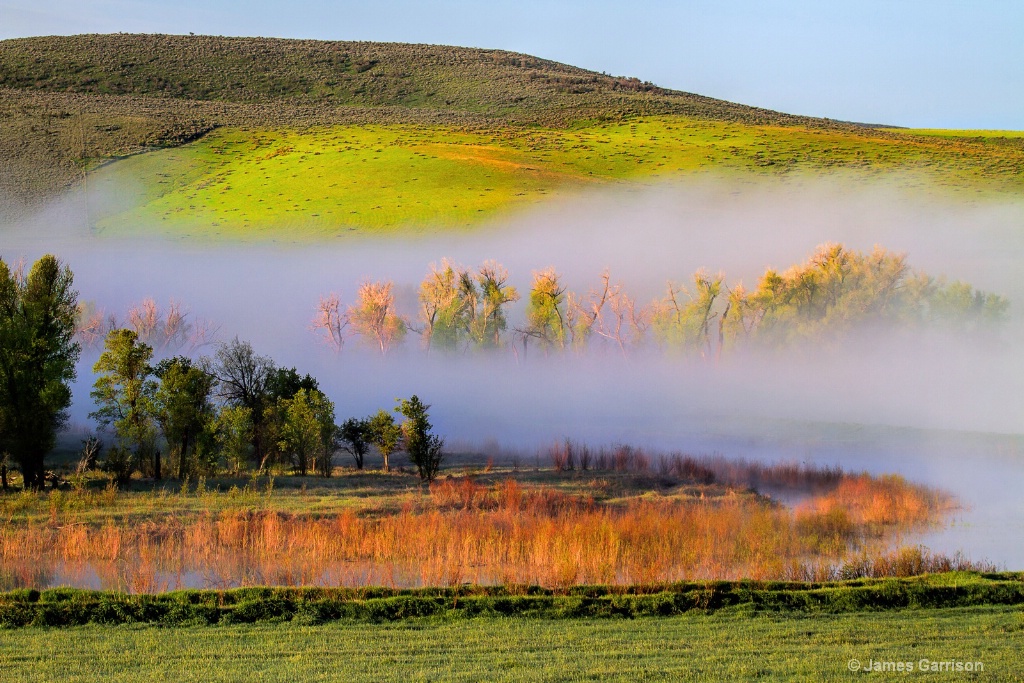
[153,356,216,479]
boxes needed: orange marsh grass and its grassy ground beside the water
[0,444,953,592]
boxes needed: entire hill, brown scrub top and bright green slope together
[0,34,1024,239]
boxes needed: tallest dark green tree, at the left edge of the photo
[0,255,81,489]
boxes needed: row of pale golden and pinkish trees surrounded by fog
[312,244,1009,357]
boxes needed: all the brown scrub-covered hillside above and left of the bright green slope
[0,34,860,209]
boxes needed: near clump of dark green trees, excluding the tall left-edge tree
[90,329,444,484]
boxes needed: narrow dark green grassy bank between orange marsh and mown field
[0,571,1024,628]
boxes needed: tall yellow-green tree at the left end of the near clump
[89,329,157,481]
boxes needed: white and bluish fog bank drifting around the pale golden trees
[0,176,1024,569]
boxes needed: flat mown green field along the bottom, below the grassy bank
[0,607,1024,682]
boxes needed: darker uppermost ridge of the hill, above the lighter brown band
[0,34,823,124]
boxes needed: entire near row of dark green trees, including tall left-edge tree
[0,255,444,489]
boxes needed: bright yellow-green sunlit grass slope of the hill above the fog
[88,117,1024,240]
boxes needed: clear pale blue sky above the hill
[0,0,1024,130]
